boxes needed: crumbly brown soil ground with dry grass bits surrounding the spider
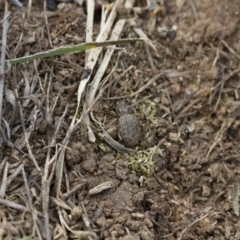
[0,0,240,240]
